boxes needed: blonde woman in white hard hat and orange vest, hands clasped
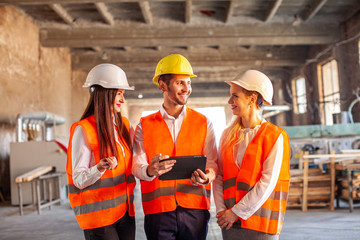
[214,70,290,240]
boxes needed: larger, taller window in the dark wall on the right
[320,60,340,125]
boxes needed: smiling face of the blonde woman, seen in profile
[228,84,252,117]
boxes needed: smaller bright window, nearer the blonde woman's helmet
[291,77,307,114]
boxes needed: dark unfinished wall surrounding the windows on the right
[292,10,360,125]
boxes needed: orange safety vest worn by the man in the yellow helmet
[140,108,211,214]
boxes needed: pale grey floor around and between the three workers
[0,184,360,240]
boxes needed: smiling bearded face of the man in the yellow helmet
[159,74,192,105]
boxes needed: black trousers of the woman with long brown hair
[84,212,135,240]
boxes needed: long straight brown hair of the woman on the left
[80,85,132,158]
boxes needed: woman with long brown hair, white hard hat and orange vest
[66,64,135,240]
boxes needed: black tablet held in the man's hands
[159,155,206,180]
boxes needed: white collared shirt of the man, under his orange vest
[132,106,217,181]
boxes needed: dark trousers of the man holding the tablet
[144,206,210,240]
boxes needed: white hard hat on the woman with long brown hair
[83,63,134,90]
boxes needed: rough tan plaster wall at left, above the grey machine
[0,6,74,199]
